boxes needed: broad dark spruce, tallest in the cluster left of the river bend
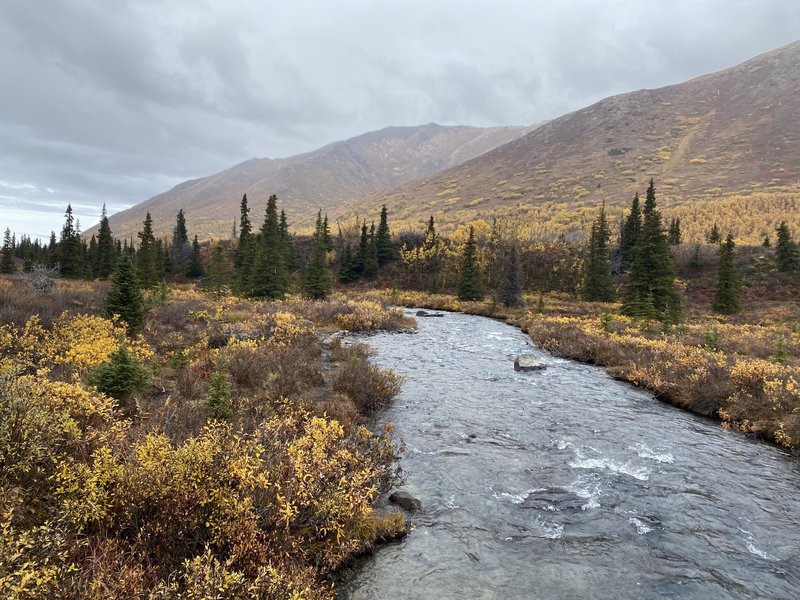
[249,194,289,299]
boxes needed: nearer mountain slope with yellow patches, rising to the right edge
[337,37,800,235]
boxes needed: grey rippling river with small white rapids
[340,314,800,600]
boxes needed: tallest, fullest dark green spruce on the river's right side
[622,179,681,322]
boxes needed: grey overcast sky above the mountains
[0,0,800,236]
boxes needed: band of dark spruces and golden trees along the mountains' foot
[6,180,800,322]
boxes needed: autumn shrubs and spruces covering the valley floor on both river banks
[0,181,800,598]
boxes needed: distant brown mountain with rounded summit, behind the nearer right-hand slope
[101,123,529,240]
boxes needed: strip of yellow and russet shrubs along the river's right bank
[360,290,800,451]
